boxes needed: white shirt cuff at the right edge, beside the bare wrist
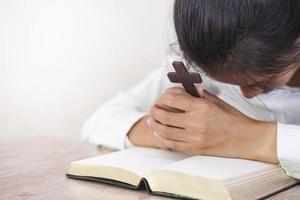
[277,123,300,179]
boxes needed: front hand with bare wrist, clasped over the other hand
[147,87,278,163]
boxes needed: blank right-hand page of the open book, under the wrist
[158,156,278,181]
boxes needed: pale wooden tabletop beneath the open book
[0,137,300,200]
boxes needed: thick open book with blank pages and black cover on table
[67,147,297,200]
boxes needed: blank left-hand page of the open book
[73,147,190,176]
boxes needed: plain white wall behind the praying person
[0,0,171,140]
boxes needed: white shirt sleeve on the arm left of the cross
[82,67,170,149]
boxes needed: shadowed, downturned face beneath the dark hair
[214,66,299,98]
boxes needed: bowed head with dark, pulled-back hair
[174,0,300,97]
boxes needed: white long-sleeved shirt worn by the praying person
[83,61,300,179]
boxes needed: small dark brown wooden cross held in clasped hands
[168,61,202,97]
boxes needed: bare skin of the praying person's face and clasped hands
[128,66,300,164]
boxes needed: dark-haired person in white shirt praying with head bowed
[83,0,300,179]
